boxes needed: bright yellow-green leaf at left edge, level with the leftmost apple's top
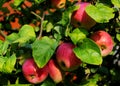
[0,54,16,73]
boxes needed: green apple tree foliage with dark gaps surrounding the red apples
[0,0,120,86]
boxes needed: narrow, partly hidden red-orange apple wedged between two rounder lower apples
[48,59,63,83]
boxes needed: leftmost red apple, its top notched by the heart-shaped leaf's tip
[22,58,48,84]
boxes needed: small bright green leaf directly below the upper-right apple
[69,28,88,45]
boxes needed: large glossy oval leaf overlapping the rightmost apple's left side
[74,38,102,65]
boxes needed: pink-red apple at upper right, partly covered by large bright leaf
[71,2,96,30]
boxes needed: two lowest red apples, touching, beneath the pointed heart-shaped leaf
[22,58,62,84]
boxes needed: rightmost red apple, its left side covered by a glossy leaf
[90,30,114,57]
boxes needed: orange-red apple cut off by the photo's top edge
[51,0,66,9]
